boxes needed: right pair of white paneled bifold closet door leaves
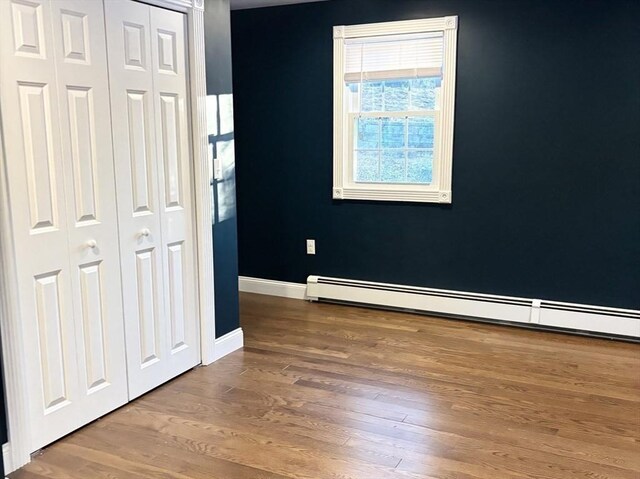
[105,0,200,399]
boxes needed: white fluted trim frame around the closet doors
[0,0,215,473]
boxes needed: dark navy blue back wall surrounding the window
[232,0,640,309]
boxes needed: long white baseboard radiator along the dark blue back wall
[307,276,640,341]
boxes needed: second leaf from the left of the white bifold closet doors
[51,0,128,434]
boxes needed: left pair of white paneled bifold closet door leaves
[0,0,127,450]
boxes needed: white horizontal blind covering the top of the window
[344,32,444,83]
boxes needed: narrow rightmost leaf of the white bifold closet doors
[149,7,200,390]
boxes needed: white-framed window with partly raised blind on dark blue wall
[333,16,458,203]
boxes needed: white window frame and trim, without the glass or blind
[333,16,458,203]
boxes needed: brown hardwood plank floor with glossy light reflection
[11,294,640,479]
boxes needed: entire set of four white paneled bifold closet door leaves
[0,0,200,451]
